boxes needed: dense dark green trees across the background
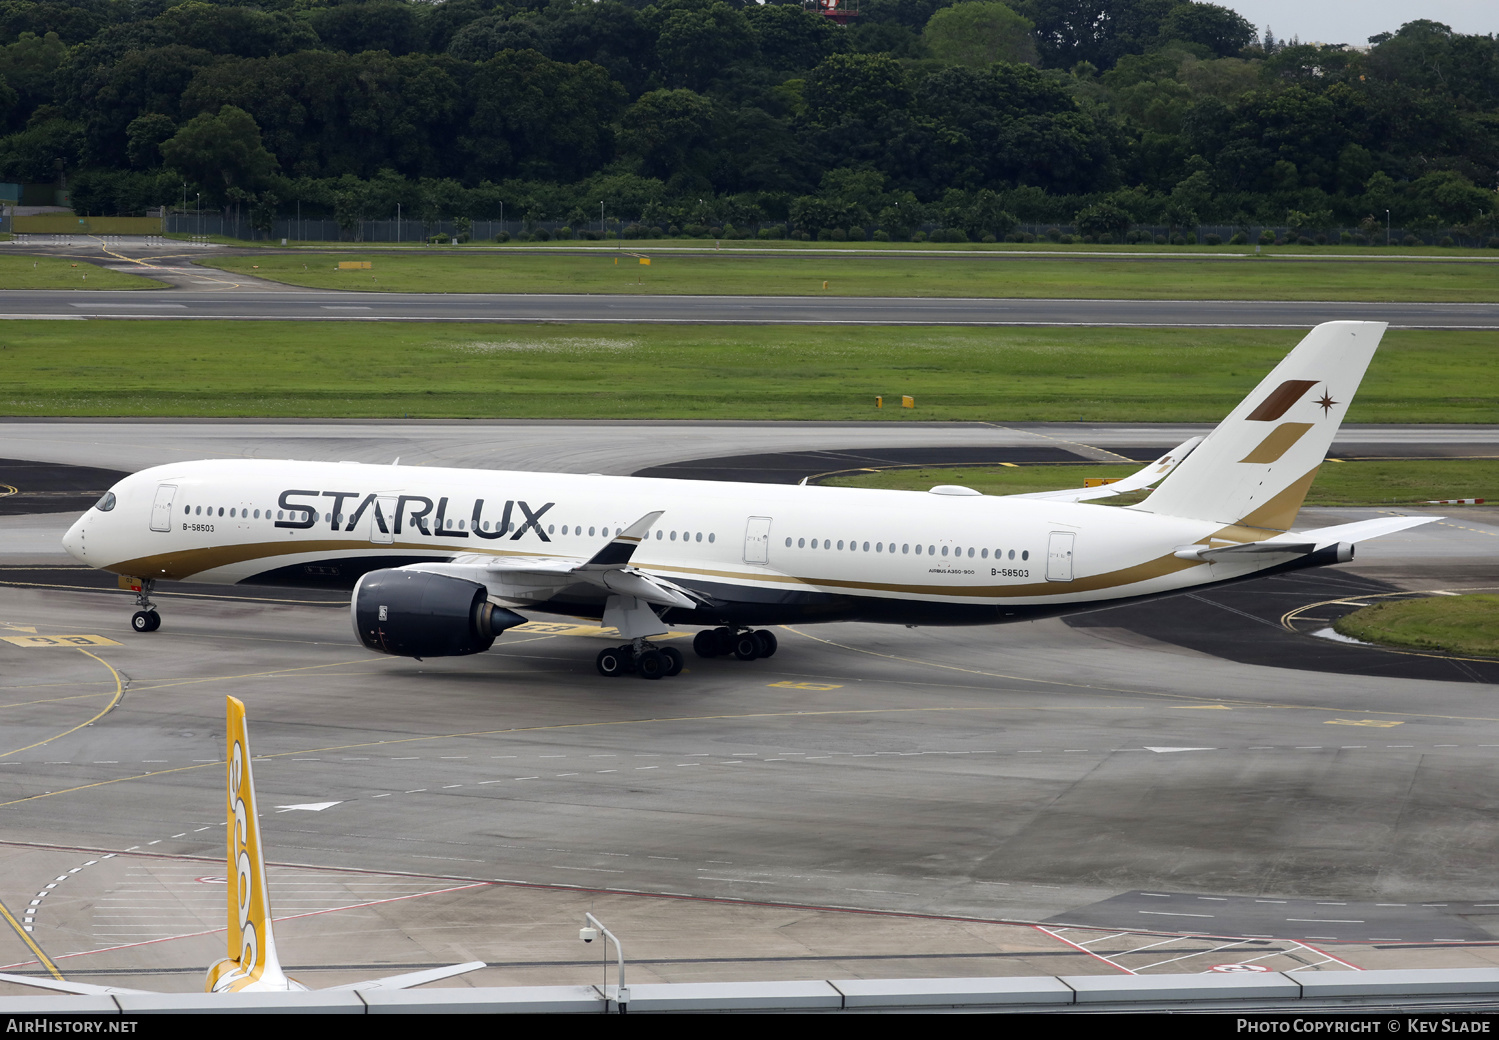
[0,0,1499,237]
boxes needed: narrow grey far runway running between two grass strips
[0,287,1499,330]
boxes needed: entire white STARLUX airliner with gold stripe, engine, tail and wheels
[64,322,1435,679]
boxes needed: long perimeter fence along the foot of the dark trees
[134,213,1499,249]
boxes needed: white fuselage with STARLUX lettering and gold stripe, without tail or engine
[64,460,1289,623]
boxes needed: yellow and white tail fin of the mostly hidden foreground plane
[204,697,300,994]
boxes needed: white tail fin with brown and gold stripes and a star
[1135,321,1387,530]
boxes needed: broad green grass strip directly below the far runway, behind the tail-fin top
[0,321,1499,423]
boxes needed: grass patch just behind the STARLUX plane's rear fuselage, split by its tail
[817,459,1499,507]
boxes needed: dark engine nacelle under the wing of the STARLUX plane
[349,571,526,658]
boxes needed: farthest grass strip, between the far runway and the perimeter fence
[204,247,1499,303]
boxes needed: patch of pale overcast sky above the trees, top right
[1216,0,1499,45]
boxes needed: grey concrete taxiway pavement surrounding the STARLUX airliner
[0,423,1499,989]
